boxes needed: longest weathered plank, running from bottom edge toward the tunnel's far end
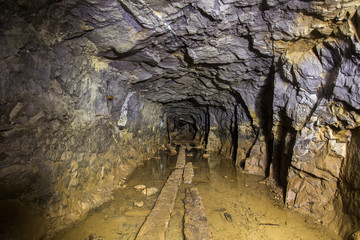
[136,147,185,240]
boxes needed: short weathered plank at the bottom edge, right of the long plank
[184,188,212,240]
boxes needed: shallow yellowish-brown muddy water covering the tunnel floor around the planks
[55,150,340,240]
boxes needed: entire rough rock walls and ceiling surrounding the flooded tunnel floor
[0,0,360,236]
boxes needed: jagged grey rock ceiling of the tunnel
[3,0,356,129]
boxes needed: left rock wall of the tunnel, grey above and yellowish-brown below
[0,3,166,239]
